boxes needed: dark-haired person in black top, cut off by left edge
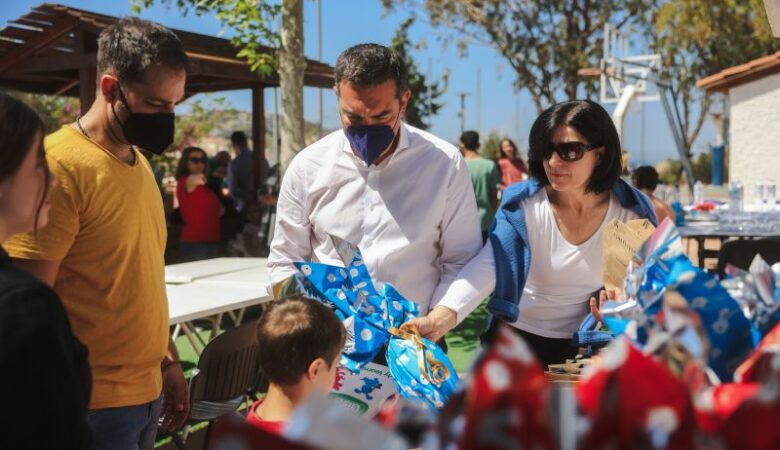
[0,92,90,449]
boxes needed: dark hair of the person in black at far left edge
[0,92,51,231]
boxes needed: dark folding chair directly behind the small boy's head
[172,321,260,450]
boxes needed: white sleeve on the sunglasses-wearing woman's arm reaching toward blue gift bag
[438,242,496,323]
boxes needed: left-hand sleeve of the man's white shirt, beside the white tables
[268,158,312,283]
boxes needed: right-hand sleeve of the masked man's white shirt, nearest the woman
[430,155,482,308]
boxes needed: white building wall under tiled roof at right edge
[729,74,780,204]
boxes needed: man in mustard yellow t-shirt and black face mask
[5,18,189,450]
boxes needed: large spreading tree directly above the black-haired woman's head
[382,0,655,112]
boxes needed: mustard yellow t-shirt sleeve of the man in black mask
[3,158,79,261]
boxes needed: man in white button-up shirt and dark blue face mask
[268,44,482,329]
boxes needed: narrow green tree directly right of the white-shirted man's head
[390,17,449,130]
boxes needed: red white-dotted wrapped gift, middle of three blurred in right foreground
[576,338,694,450]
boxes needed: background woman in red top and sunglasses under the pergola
[176,147,221,261]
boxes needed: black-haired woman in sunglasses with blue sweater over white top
[414,100,656,367]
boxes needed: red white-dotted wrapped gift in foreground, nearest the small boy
[457,325,554,450]
